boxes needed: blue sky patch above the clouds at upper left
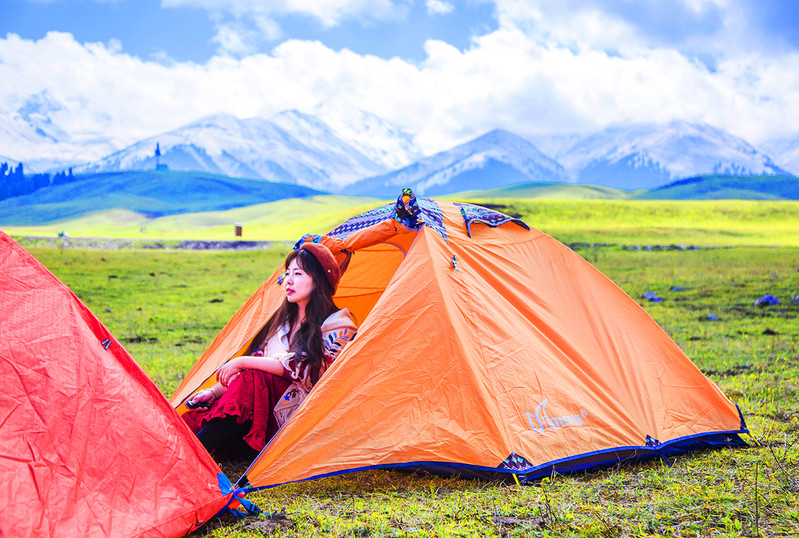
[0,0,497,63]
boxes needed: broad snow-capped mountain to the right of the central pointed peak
[555,121,787,189]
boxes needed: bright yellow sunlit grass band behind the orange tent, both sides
[3,195,799,246]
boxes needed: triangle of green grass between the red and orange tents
[23,247,287,395]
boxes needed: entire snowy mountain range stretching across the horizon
[0,102,799,195]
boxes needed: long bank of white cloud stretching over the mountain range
[0,0,799,163]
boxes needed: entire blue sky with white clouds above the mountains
[0,0,799,158]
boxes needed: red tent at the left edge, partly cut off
[0,232,232,537]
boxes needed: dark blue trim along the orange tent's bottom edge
[242,428,749,491]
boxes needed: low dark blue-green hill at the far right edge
[632,175,799,200]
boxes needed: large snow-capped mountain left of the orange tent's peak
[76,110,386,190]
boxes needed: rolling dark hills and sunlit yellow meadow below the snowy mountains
[6,172,799,245]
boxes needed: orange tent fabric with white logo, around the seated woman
[172,199,746,488]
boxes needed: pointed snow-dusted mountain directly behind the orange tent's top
[349,130,566,196]
